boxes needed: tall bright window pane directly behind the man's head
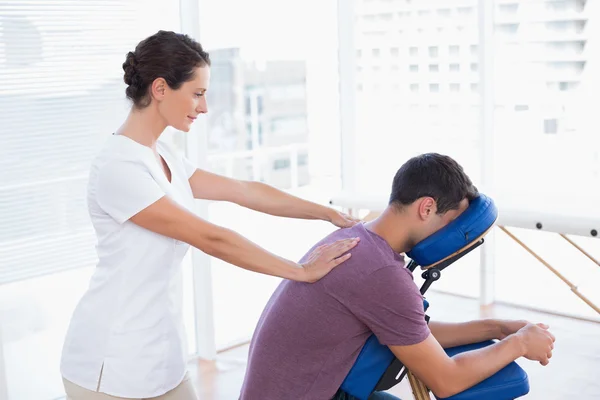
[352,0,481,296]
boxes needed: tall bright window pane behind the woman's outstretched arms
[200,0,340,349]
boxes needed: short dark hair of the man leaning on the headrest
[389,153,479,214]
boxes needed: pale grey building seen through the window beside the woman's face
[207,48,309,188]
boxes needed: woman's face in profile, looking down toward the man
[158,65,210,132]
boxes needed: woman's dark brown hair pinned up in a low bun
[123,31,210,108]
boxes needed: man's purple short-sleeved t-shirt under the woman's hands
[240,224,429,400]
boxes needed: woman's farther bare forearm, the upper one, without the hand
[238,182,333,221]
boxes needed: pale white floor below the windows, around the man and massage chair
[190,291,600,400]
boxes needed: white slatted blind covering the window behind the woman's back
[0,0,180,284]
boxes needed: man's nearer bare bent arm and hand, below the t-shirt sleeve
[389,324,554,397]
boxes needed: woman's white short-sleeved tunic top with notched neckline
[61,135,195,398]
